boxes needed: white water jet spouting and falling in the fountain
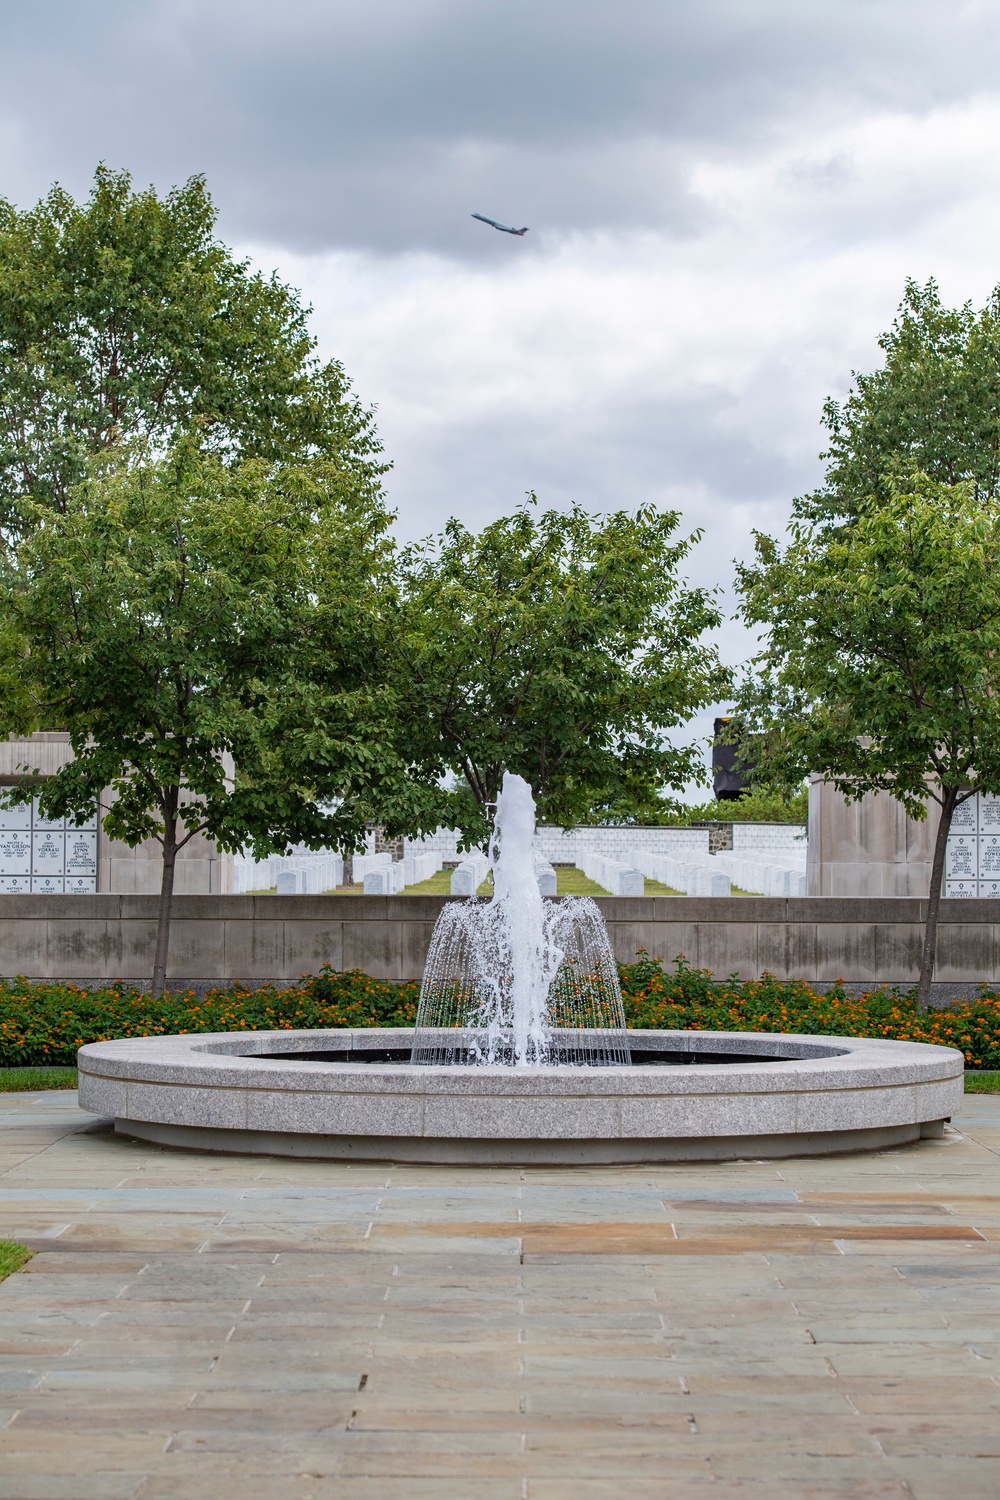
[412,771,631,1067]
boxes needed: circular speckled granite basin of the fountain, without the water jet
[79,1029,964,1164]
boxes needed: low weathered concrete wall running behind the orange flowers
[0,894,1000,986]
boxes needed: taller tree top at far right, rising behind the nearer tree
[796,281,1000,524]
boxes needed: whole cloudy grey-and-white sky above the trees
[0,0,1000,792]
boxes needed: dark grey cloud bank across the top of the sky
[0,0,997,252]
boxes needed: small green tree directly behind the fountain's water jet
[397,497,729,843]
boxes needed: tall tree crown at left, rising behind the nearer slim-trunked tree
[0,167,381,530]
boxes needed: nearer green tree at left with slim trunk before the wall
[0,443,438,992]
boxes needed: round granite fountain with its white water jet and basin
[78,774,964,1164]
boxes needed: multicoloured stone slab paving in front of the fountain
[0,1094,1000,1500]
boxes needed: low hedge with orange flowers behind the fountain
[0,953,1000,1070]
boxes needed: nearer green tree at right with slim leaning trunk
[738,476,1000,1007]
